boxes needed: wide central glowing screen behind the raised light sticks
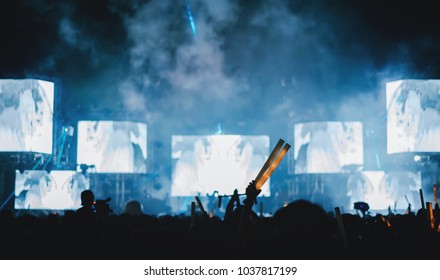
[171,135,270,196]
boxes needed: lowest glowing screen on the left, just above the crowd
[15,170,90,210]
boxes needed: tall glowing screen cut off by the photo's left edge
[0,79,54,154]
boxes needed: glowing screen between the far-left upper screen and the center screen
[77,121,147,173]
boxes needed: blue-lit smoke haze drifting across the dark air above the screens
[3,0,432,139]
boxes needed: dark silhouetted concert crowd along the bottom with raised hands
[0,182,440,260]
